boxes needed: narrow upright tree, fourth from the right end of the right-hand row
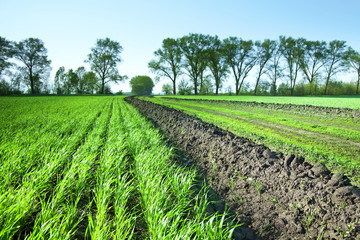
[280,36,303,96]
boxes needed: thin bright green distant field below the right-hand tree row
[159,95,360,109]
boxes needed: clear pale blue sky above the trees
[0,0,360,92]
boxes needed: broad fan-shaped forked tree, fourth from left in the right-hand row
[224,37,256,95]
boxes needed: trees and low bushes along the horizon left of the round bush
[0,37,127,95]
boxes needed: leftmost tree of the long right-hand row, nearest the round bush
[148,38,182,95]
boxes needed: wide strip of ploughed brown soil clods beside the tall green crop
[126,98,360,239]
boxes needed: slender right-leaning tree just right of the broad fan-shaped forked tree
[254,39,276,95]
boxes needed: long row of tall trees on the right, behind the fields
[148,33,360,96]
